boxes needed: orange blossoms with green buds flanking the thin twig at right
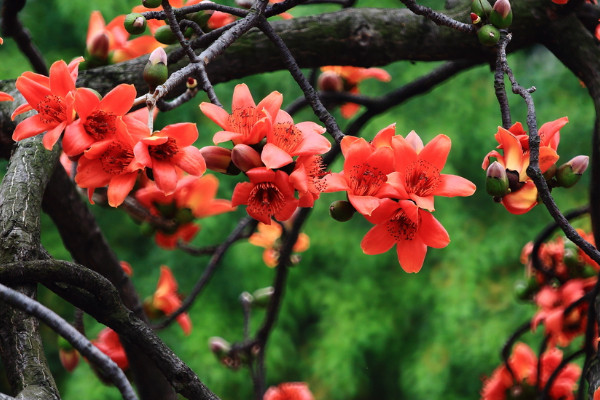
[481,117,588,214]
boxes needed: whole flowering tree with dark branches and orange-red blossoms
[0,0,600,400]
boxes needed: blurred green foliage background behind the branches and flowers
[0,0,594,400]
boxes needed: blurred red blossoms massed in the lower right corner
[482,230,600,400]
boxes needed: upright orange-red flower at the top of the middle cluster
[200,83,283,145]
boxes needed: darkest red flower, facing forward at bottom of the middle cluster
[231,167,298,225]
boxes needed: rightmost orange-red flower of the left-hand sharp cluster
[134,122,206,194]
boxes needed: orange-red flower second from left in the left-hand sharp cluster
[62,84,136,156]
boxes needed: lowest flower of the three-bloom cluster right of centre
[360,199,450,272]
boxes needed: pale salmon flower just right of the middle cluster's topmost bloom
[261,110,331,169]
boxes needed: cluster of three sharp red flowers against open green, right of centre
[323,125,475,272]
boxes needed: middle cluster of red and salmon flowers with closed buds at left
[200,84,331,225]
